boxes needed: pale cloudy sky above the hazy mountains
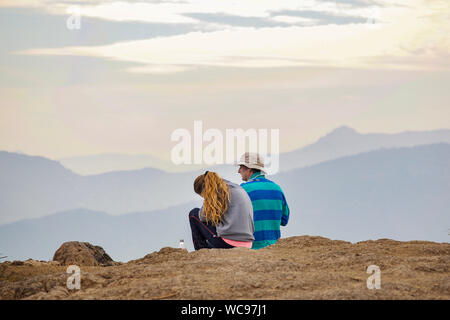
[0,0,450,159]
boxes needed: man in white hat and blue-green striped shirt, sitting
[238,152,289,249]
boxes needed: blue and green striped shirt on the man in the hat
[241,172,289,249]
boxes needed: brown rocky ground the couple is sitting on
[0,236,450,299]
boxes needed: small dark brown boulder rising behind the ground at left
[53,241,115,266]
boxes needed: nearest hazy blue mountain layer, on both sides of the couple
[0,144,450,261]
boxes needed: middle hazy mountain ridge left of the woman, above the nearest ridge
[0,152,207,224]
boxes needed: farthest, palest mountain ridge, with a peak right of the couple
[57,126,450,175]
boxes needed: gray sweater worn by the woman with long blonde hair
[199,179,255,241]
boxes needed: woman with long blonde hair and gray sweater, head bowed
[189,171,255,250]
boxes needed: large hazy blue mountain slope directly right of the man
[276,144,450,242]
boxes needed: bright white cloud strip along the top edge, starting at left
[0,0,380,25]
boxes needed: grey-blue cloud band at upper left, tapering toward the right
[0,8,198,52]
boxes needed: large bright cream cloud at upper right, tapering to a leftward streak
[7,0,450,73]
